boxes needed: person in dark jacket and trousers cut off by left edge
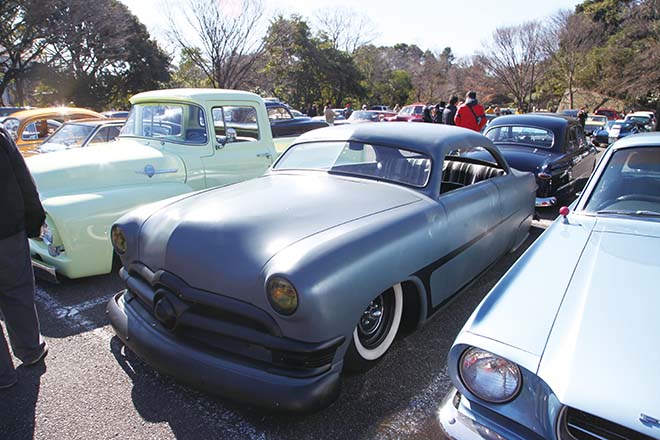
[0,127,48,389]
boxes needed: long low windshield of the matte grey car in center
[273,141,431,188]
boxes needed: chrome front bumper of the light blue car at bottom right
[438,388,541,440]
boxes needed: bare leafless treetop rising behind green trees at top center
[315,7,377,53]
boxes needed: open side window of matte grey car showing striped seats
[440,147,506,194]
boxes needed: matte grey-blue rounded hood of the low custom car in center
[139,172,421,300]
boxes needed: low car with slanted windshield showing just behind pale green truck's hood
[38,118,126,153]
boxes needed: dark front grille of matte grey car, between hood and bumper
[122,264,344,377]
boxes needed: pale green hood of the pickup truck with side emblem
[25,139,186,198]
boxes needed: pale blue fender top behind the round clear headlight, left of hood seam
[464,215,595,372]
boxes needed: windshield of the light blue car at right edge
[585,147,660,217]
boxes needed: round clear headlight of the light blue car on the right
[459,347,522,403]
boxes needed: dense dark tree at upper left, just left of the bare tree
[44,0,169,109]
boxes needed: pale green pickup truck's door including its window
[202,102,274,187]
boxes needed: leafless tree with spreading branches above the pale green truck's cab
[170,0,264,89]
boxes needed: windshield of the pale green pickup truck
[119,103,207,144]
